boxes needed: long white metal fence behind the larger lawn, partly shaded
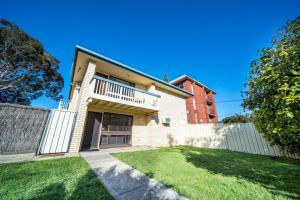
[175,123,296,158]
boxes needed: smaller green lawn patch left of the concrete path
[0,157,113,200]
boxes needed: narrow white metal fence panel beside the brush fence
[39,109,76,154]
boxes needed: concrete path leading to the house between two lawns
[80,147,186,200]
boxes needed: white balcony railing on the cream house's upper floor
[91,76,160,110]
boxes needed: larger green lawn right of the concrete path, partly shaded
[113,147,300,200]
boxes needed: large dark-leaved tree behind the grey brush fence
[0,19,64,105]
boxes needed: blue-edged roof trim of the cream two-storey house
[69,45,194,96]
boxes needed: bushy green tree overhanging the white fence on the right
[243,17,300,154]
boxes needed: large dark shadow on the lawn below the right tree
[181,147,300,199]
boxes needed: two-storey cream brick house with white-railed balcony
[68,46,193,152]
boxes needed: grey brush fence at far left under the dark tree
[0,103,49,154]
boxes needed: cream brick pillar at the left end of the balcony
[69,61,96,152]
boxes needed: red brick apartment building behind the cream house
[170,75,218,124]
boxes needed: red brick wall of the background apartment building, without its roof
[178,80,218,124]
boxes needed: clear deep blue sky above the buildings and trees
[0,0,300,118]
